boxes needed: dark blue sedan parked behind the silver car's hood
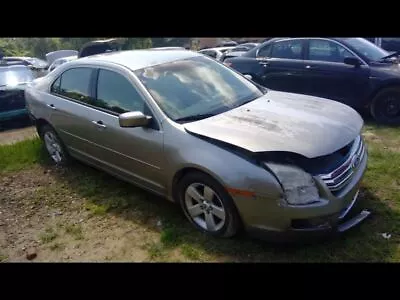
[224,37,400,124]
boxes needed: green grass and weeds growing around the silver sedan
[0,124,400,262]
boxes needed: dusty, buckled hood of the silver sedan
[183,90,363,158]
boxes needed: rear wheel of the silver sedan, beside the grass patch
[40,125,70,166]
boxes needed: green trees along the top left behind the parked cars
[0,37,191,59]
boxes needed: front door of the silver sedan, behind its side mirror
[86,69,166,193]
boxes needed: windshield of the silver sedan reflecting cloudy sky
[135,56,263,121]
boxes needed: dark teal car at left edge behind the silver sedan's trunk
[0,62,35,122]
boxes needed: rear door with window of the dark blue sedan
[257,39,305,94]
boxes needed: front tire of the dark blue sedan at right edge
[370,87,400,125]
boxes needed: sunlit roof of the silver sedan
[70,49,201,71]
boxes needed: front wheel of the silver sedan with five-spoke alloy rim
[178,172,240,238]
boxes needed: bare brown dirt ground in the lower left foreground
[0,167,191,262]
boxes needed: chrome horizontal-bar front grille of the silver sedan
[319,136,365,194]
